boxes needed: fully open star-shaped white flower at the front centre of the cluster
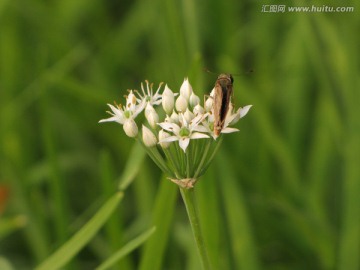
[159,114,209,153]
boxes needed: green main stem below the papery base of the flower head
[180,188,211,270]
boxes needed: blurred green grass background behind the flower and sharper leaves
[0,0,360,270]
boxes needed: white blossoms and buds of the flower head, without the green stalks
[100,79,251,153]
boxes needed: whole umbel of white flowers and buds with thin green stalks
[99,78,252,188]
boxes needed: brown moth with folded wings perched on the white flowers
[213,74,234,137]
